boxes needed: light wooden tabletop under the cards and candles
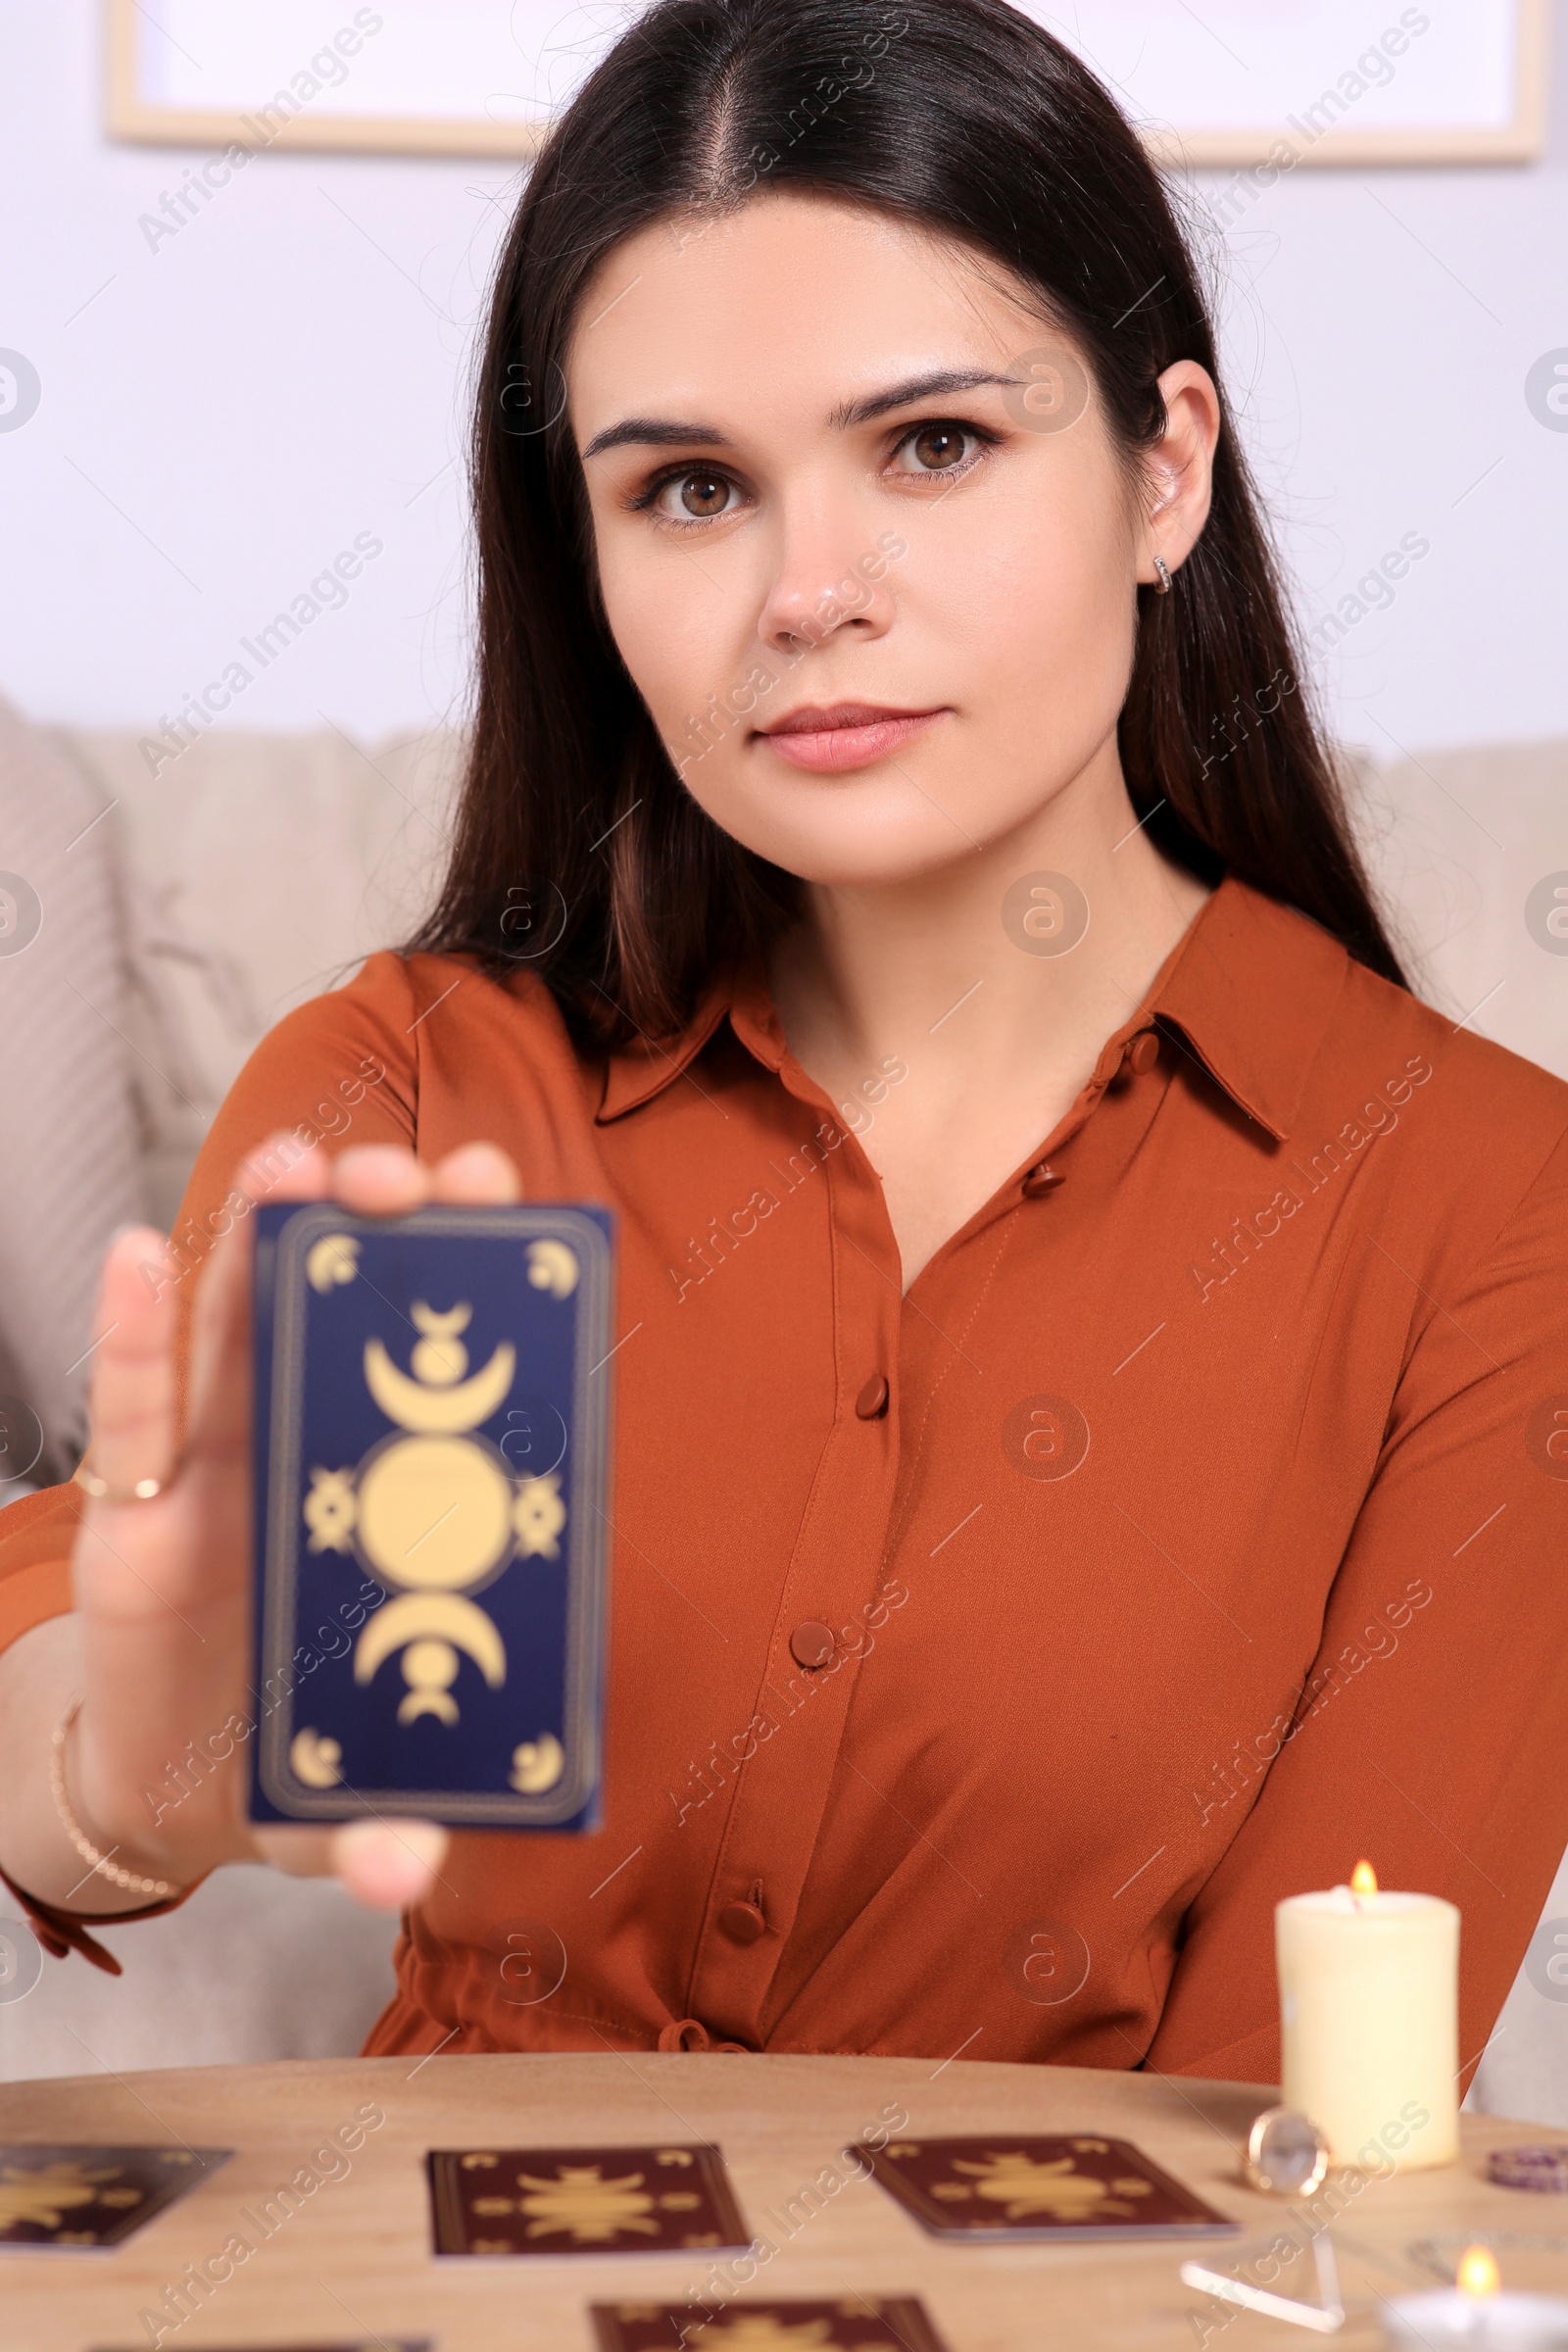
[0,2053,1568,2352]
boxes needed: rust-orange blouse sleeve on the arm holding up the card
[0,951,418,1974]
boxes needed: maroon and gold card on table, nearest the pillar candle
[856,2131,1242,2244]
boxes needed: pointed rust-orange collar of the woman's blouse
[597,875,1349,1143]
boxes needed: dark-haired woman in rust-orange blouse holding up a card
[0,0,1568,2082]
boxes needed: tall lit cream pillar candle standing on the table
[1274,1863,1460,2171]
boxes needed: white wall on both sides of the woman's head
[0,0,1568,758]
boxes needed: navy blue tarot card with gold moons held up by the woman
[252,1201,613,1830]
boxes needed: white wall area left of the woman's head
[0,0,514,734]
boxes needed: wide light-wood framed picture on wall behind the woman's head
[104,0,1549,170]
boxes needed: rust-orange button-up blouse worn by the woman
[0,880,1568,2082]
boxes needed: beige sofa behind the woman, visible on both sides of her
[0,706,1568,2124]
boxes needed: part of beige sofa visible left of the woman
[0,706,459,2082]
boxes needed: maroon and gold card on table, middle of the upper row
[428,2142,750,2256]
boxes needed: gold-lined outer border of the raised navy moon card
[254,1200,613,1830]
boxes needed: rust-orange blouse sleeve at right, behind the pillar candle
[1145,1139,1568,2083]
